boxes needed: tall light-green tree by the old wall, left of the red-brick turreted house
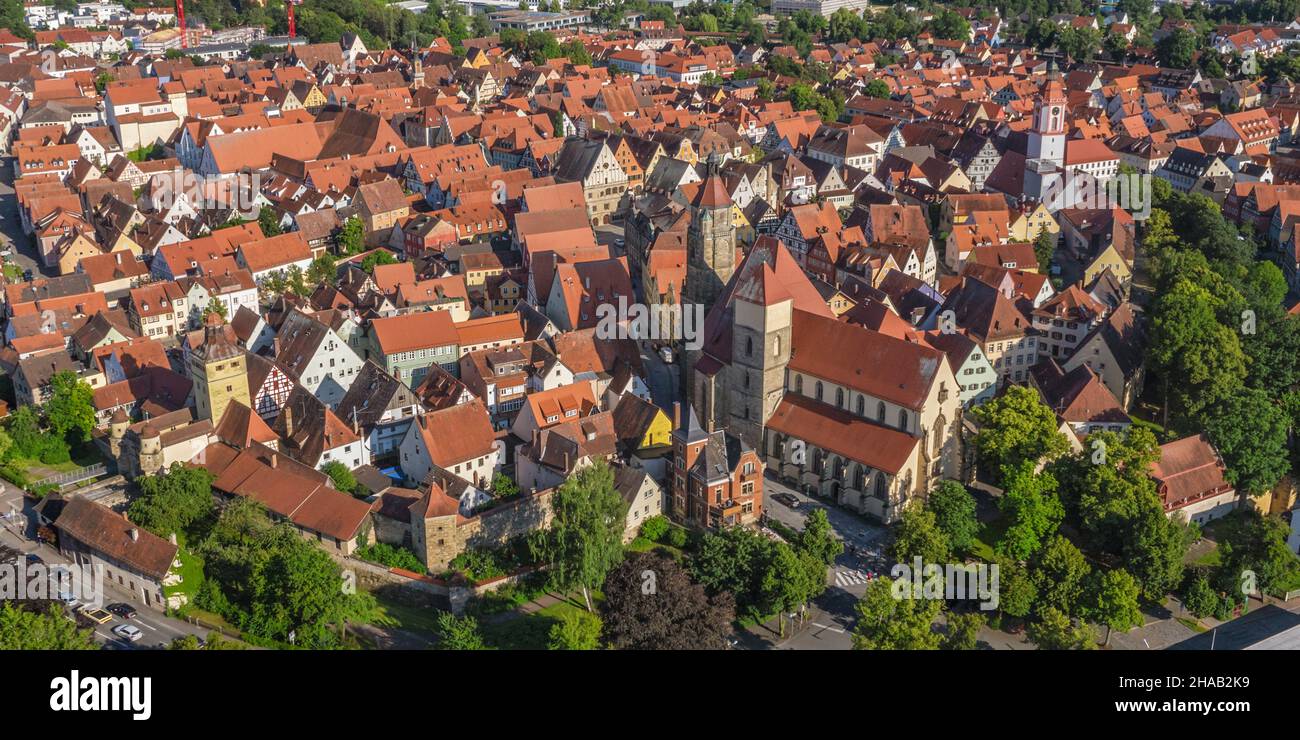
[546,462,627,611]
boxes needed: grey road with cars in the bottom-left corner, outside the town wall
[0,484,208,650]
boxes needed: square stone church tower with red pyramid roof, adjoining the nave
[727,238,794,449]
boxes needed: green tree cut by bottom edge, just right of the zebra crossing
[853,579,943,650]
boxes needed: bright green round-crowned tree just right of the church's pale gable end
[971,385,1070,479]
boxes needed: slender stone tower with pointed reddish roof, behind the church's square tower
[681,157,736,313]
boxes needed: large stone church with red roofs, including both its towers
[683,162,963,523]
